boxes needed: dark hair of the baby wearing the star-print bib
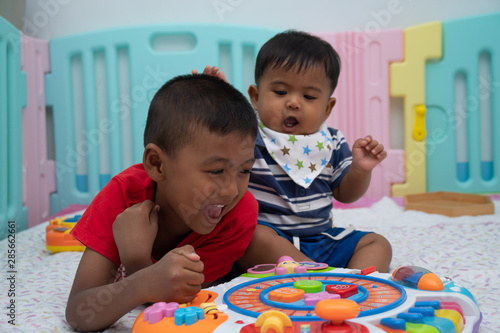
[255,30,340,93]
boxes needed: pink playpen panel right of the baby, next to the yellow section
[318,30,404,197]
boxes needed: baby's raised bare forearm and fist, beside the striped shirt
[333,135,387,203]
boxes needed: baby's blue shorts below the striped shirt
[258,221,370,268]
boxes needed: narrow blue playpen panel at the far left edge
[0,17,28,239]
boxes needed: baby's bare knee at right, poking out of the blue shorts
[347,233,392,273]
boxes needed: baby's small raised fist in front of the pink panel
[352,135,387,171]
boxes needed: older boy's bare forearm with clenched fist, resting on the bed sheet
[66,245,204,331]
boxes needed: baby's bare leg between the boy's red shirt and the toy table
[238,224,311,272]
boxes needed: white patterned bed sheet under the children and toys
[0,198,500,333]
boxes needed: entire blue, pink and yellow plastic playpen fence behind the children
[0,13,500,239]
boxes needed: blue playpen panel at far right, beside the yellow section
[426,13,500,193]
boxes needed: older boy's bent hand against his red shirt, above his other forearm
[113,200,160,274]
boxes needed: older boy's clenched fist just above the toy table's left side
[145,245,205,303]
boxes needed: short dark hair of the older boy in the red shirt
[144,74,258,156]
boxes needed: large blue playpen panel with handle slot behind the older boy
[45,25,278,213]
